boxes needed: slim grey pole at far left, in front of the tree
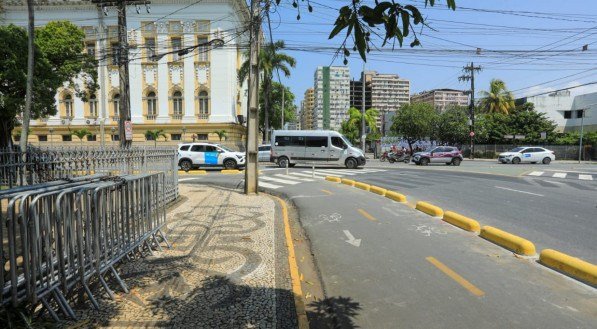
[19,0,35,152]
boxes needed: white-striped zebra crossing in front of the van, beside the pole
[259,168,386,190]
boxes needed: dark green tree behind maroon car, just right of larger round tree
[435,106,469,145]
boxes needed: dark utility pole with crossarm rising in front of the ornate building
[92,0,150,148]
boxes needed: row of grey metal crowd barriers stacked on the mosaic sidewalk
[0,173,170,320]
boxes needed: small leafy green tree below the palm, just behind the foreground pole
[259,81,296,131]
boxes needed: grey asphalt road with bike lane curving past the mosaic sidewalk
[181,168,597,328]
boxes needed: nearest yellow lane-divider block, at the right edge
[539,249,597,287]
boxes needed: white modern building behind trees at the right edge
[516,90,597,132]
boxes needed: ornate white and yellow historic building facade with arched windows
[0,0,249,144]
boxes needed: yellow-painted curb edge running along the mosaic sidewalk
[272,195,309,329]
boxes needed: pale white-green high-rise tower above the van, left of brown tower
[313,66,350,130]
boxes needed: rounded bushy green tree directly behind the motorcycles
[390,103,438,153]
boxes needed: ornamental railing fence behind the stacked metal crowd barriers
[0,146,178,202]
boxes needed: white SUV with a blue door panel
[178,143,245,171]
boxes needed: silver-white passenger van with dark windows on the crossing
[270,130,366,169]
